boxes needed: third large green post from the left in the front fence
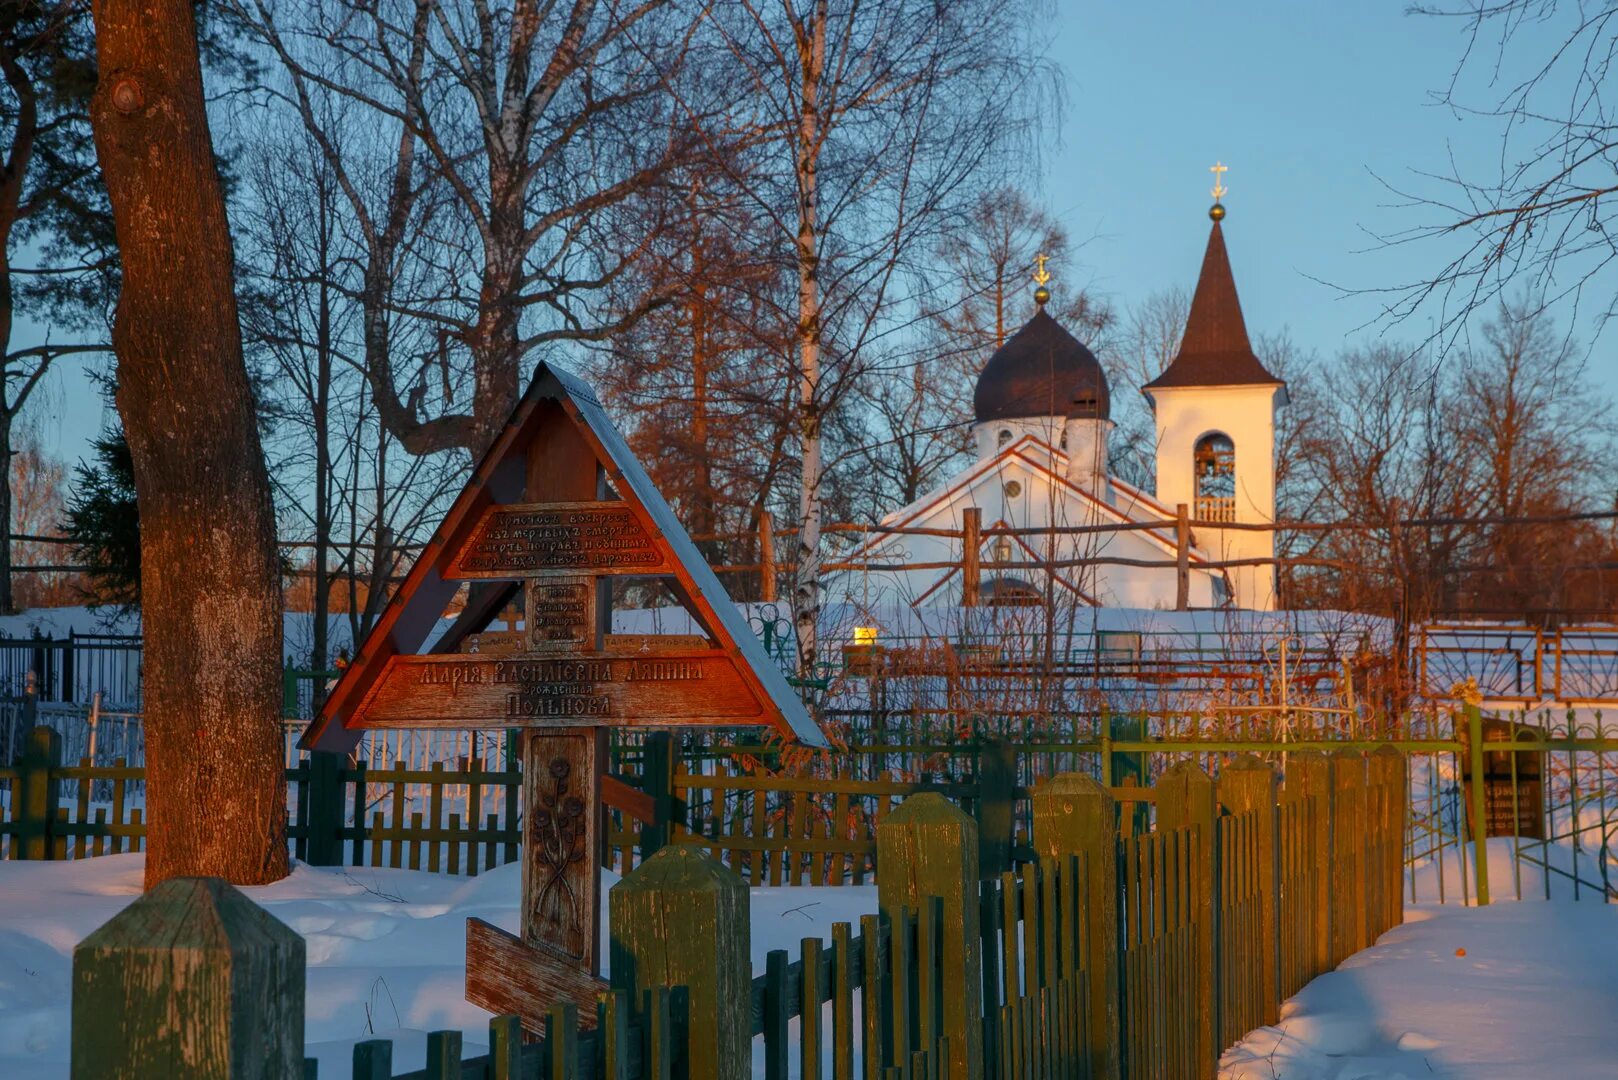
[877,792,984,1080]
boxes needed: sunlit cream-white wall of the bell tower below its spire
[1152,385,1280,610]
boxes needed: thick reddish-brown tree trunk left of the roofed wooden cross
[91,0,286,887]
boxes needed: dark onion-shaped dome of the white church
[972,304,1112,423]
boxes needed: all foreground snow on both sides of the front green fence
[0,844,1618,1080]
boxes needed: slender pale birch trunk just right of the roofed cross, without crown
[793,8,827,678]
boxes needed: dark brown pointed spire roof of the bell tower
[1141,220,1286,390]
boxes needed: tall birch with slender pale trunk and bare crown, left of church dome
[714,0,1053,675]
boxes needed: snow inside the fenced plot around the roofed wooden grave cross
[0,855,877,1080]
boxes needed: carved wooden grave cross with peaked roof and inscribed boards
[304,366,824,1033]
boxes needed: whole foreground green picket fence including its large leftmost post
[63,748,1404,1080]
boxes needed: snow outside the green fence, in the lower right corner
[1220,840,1618,1080]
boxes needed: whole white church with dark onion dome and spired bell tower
[845,204,1286,610]
